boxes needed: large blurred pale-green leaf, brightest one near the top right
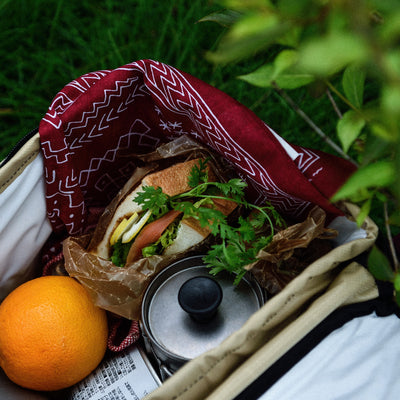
[300,31,368,76]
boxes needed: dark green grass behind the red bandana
[0,0,335,160]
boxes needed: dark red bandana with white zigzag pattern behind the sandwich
[39,60,355,235]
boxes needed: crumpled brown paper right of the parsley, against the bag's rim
[246,206,337,295]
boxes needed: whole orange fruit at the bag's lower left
[0,276,108,391]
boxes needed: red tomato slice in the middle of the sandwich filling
[126,210,182,264]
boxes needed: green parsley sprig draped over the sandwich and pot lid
[134,160,284,284]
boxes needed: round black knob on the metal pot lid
[178,276,222,322]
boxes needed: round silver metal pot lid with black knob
[142,256,264,360]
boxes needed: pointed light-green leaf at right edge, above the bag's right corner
[332,161,395,201]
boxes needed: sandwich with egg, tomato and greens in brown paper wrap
[88,158,237,266]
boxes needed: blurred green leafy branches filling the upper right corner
[202,0,400,305]
